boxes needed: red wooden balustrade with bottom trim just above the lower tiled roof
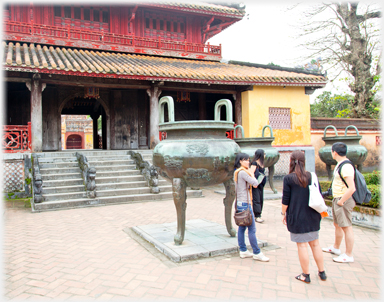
[3,21,221,60]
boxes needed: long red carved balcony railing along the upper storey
[3,21,221,58]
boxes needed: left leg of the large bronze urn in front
[172,178,187,245]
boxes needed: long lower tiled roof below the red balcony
[2,42,327,86]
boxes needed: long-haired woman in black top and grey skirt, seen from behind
[281,151,327,283]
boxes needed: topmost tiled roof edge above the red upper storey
[140,1,245,18]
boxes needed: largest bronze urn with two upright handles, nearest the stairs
[153,96,240,245]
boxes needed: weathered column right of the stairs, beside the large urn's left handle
[147,86,162,149]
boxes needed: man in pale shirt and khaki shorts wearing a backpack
[323,142,356,263]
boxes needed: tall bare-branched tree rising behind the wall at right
[294,2,381,117]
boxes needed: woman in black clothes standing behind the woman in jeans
[251,149,267,223]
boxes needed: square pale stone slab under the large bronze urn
[129,219,268,262]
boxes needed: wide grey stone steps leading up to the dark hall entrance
[32,150,202,212]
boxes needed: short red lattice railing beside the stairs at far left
[2,122,32,153]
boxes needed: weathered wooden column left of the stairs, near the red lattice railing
[26,73,46,152]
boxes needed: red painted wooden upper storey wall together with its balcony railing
[3,3,228,61]
